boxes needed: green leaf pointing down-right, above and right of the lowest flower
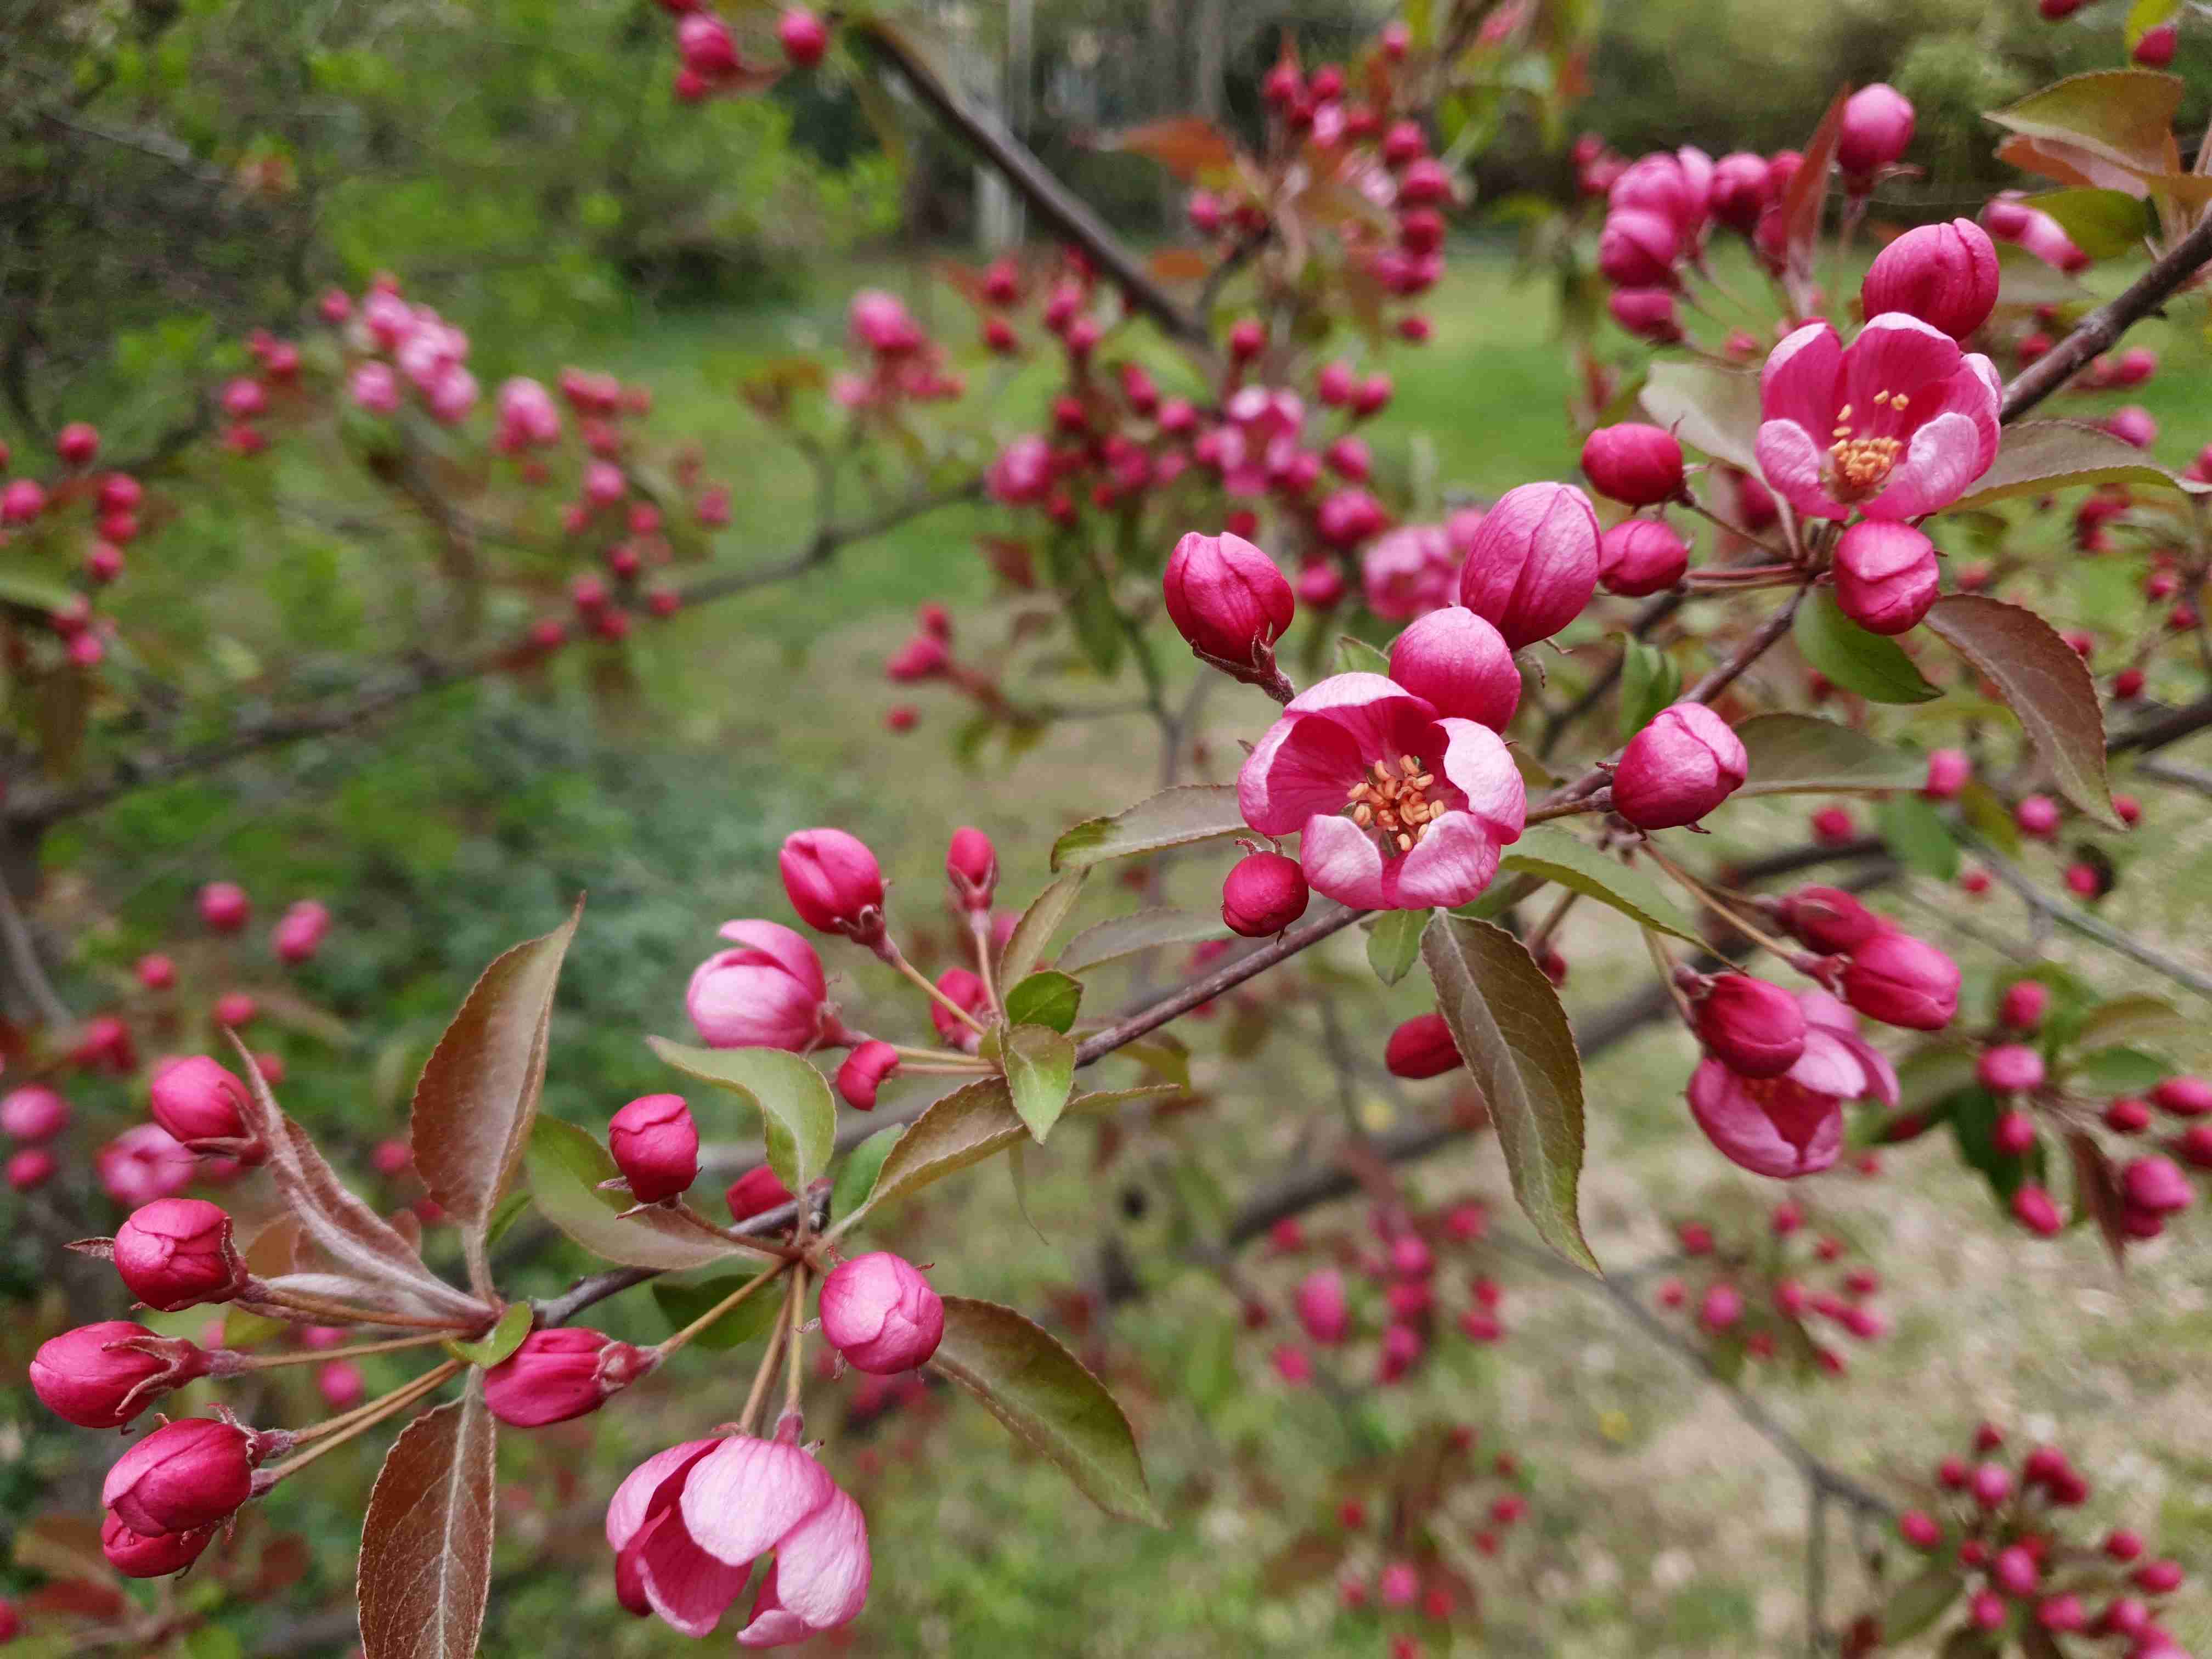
[931,1296,1164,1526]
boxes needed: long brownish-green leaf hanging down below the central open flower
[1420,916,1597,1274]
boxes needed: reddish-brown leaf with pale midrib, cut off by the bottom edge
[358,1385,498,1659]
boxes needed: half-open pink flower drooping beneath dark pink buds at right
[1690,991,1898,1181]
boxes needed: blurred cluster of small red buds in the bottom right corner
[1845,1423,2188,1659]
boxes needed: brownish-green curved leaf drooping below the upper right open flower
[1927,593,2124,830]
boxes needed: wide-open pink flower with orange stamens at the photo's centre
[1237,675,1528,909]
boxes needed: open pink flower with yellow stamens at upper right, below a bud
[1758,312,2002,520]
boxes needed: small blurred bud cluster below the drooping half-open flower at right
[1655,1199,1889,1376]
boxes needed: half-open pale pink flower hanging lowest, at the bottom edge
[606,1434,870,1648]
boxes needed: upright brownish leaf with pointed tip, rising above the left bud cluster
[407,898,584,1294]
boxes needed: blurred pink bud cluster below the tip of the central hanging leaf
[1274,1199,1506,1387]
